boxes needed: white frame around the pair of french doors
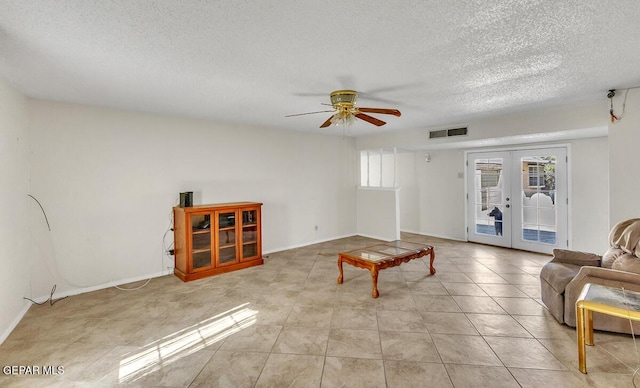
[463,143,573,253]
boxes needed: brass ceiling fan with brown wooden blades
[285,90,400,128]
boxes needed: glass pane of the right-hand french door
[520,155,557,244]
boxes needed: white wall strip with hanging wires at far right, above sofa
[609,89,640,226]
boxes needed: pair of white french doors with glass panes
[467,147,568,253]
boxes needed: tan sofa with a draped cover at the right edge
[540,218,640,333]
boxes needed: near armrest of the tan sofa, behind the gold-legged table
[564,267,640,326]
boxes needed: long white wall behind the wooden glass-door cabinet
[29,100,357,295]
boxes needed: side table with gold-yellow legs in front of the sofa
[576,283,640,373]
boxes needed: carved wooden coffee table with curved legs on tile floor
[338,240,436,298]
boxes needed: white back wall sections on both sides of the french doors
[400,138,609,254]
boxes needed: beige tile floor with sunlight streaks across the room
[0,233,640,388]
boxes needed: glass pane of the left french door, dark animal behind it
[473,158,503,236]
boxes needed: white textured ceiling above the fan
[0,0,640,136]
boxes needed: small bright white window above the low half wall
[360,149,397,187]
